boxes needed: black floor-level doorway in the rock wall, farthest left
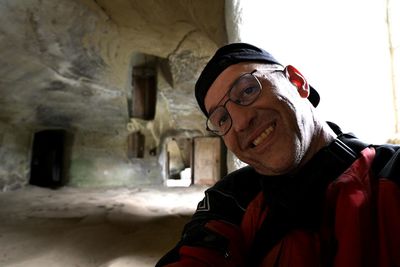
[29,130,66,189]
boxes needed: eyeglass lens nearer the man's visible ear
[229,73,261,106]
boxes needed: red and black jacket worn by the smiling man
[157,137,400,267]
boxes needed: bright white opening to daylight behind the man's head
[234,0,395,143]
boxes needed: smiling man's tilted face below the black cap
[204,63,315,175]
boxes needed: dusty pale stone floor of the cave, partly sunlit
[0,186,206,267]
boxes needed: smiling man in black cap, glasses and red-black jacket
[157,43,400,267]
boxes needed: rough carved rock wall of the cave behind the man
[0,0,227,190]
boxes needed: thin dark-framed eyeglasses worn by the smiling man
[206,70,262,136]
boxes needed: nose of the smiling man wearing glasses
[227,102,255,132]
